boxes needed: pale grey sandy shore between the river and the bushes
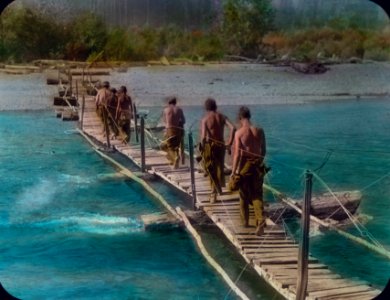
[0,62,390,110]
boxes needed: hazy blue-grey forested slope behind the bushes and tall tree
[16,0,386,29]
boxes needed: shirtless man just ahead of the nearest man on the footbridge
[200,98,235,203]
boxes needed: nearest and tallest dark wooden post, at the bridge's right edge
[296,171,313,300]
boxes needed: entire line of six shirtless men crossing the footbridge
[95,81,266,235]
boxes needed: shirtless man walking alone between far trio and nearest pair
[161,97,186,169]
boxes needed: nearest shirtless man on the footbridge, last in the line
[231,106,266,235]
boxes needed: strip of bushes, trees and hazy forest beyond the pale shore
[0,0,390,62]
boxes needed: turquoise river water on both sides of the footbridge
[0,71,390,299]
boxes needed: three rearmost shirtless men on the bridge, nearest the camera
[161,97,266,235]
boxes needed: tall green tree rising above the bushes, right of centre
[222,0,274,56]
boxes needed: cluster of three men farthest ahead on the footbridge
[95,81,134,143]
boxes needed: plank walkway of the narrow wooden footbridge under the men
[74,96,380,300]
